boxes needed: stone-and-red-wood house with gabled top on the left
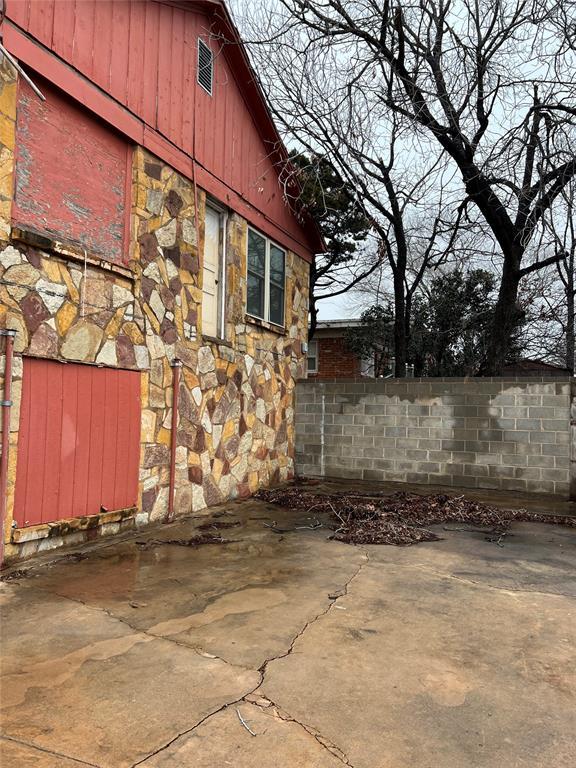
[0,0,322,558]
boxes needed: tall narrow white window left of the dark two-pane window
[202,205,226,339]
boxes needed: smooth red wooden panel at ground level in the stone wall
[14,358,140,527]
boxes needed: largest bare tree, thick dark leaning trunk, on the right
[235,0,576,375]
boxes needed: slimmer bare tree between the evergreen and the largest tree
[232,4,463,376]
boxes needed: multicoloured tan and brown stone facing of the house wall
[0,60,308,556]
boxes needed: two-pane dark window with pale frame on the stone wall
[247,229,286,325]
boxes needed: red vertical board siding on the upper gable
[6,0,310,257]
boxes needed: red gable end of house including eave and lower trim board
[2,0,324,260]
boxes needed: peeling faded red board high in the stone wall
[12,78,131,262]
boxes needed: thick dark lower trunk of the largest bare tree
[481,254,520,376]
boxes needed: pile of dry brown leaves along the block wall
[257,487,576,546]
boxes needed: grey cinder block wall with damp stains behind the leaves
[296,378,576,496]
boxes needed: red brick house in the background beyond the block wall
[307,319,374,379]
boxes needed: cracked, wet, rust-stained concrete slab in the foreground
[0,485,576,768]
